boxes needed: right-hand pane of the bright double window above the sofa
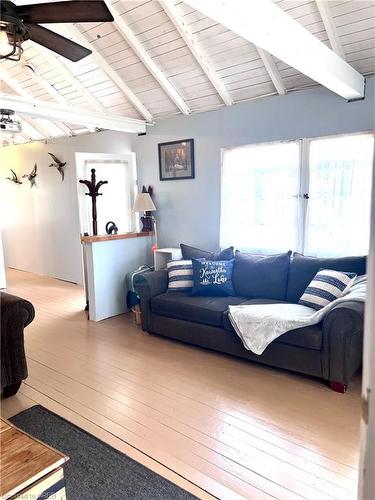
[305,135,374,257]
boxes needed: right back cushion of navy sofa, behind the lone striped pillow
[286,252,366,303]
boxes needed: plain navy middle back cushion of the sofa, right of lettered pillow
[233,251,292,300]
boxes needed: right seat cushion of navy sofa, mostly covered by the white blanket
[223,299,322,350]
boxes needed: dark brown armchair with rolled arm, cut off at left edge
[0,292,35,398]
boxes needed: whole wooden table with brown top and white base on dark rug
[0,419,68,500]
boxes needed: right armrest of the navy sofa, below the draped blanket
[323,301,365,386]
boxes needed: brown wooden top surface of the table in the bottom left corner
[0,419,68,499]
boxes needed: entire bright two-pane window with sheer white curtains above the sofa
[220,134,374,256]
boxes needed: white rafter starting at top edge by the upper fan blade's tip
[106,0,190,115]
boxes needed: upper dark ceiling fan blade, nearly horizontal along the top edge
[17,0,113,23]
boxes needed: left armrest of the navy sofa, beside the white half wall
[134,269,168,331]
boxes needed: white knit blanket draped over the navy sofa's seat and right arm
[229,276,367,354]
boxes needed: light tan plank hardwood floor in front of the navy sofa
[2,270,360,500]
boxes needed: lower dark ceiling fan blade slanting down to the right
[26,24,91,62]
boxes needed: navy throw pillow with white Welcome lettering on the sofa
[191,259,234,297]
